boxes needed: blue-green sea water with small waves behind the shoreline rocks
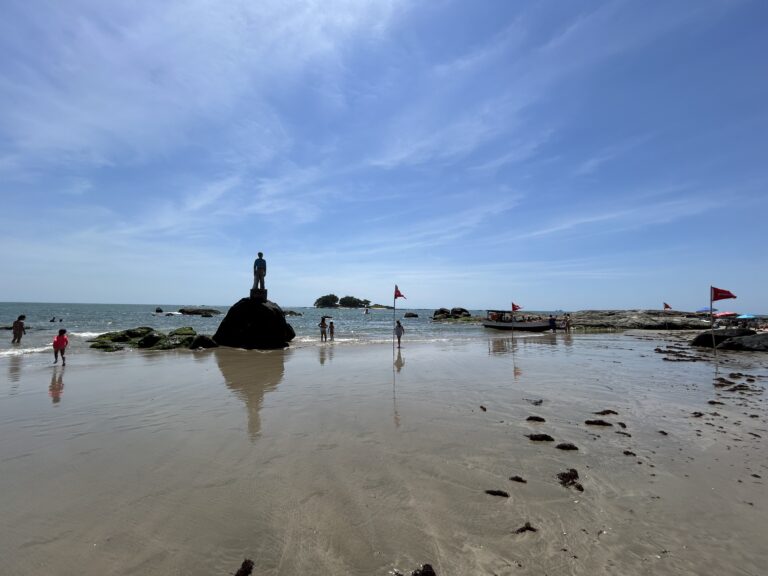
[0,302,500,357]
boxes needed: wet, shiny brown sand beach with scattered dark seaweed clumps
[0,333,768,576]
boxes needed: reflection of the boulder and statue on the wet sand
[213,348,289,439]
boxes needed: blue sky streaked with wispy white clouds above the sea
[0,0,768,313]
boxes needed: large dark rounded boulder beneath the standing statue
[213,298,296,350]
